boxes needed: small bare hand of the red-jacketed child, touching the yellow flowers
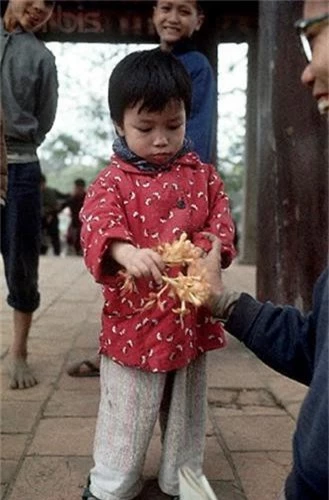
[110,242,165,285]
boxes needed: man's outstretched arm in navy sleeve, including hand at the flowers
[201,234,318,385]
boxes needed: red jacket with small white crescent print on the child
[80,153,235,372]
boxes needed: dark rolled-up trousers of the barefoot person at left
[1,162,41,313]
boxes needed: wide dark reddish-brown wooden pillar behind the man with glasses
[257,0,328,310]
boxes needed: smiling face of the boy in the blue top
[153,0,204,50]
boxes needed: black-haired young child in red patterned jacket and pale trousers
[81,49,235,500]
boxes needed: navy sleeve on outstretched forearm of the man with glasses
[225,293,316,385]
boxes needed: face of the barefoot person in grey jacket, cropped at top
[5,0,54,31]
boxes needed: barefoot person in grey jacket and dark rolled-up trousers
[0,0,58,389]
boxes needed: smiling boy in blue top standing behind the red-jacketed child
[153,0,217,163]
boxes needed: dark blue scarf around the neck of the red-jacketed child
[113,137,192,172]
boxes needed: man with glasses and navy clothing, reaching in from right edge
[197,0,329,500]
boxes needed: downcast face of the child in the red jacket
[116,100,186,165]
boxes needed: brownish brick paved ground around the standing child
[1,256,305,500]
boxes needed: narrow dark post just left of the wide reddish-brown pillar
[239,32,258,264]
